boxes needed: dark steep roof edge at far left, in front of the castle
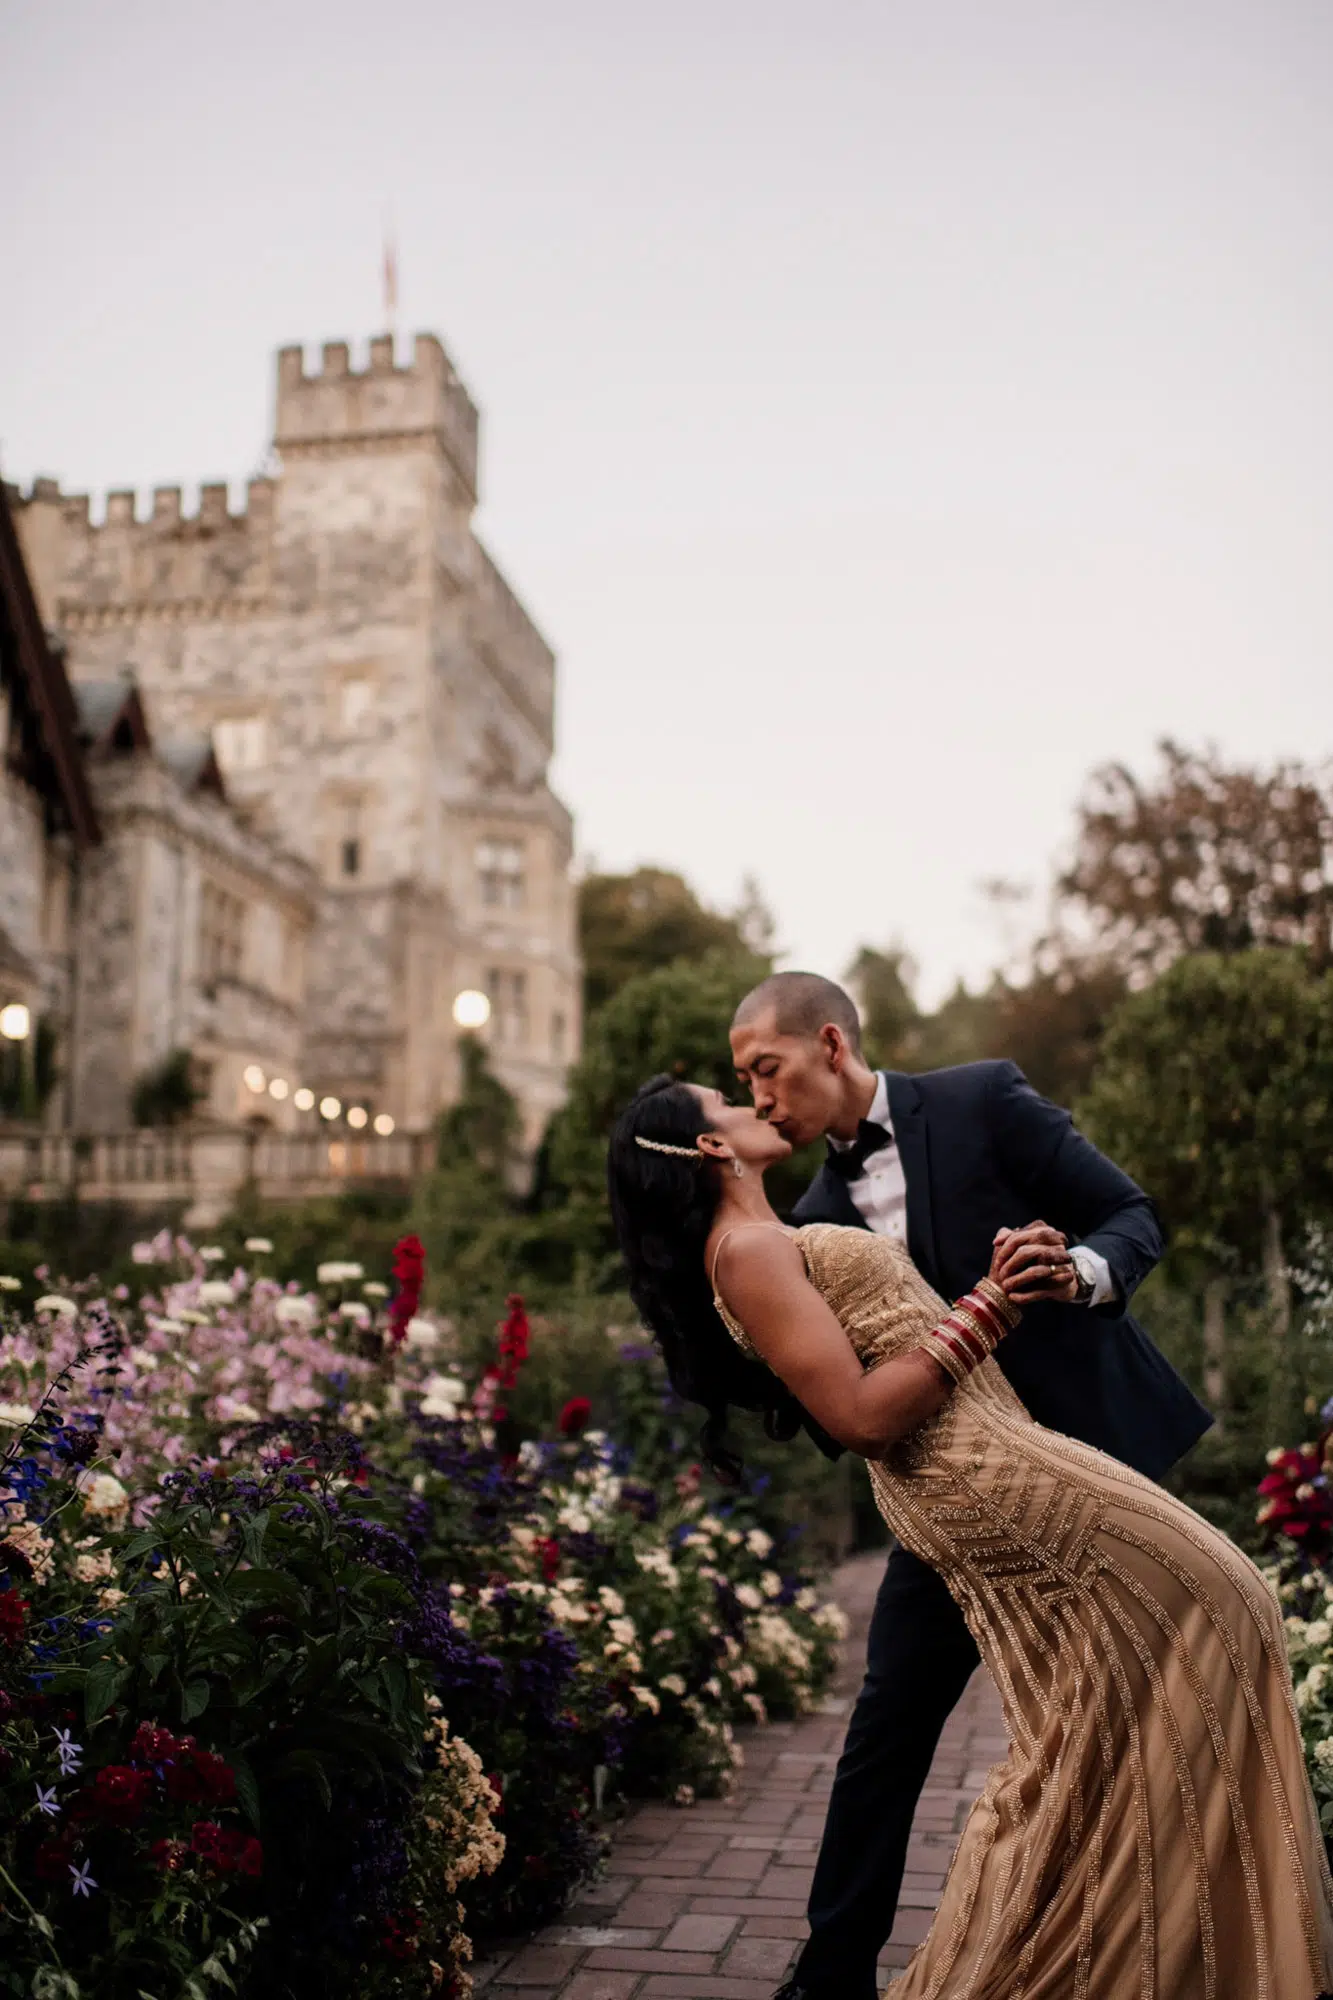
[0,482,102,846]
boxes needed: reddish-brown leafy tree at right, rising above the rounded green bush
[1059,740,1333,972]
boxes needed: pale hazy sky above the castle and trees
[0,0,1333,996]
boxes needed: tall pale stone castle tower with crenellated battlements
[20,334,580,1142]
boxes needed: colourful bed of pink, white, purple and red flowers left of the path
[0,1238,841,2000]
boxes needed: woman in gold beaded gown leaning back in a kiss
[608,1078,1333,2000]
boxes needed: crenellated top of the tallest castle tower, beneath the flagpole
[274,334,478,500]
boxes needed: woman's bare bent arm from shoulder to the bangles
[719,1230,955,1458]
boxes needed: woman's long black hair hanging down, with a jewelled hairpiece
[606,1076,801,1484]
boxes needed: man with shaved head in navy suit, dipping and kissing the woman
[731,972,1211,2000]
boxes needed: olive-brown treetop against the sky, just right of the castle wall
[578,868,773,1016]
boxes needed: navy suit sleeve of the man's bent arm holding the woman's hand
[989,1062,1165,1318]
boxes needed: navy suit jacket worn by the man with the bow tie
[793,1062,1213,1478]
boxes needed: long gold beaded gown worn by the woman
[719,1222,1333,2000]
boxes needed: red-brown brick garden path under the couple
[474,1556,1005,2000]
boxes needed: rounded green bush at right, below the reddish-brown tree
[1081,950,1333,1270]
